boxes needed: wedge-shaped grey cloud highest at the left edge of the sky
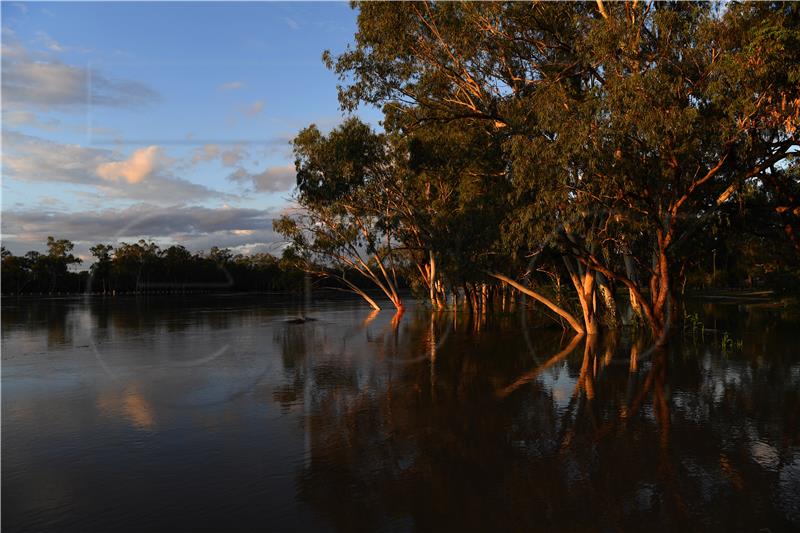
[2,42,159,111]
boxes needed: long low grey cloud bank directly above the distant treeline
[2,204,282,255]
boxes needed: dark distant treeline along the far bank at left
[2,237,305,294]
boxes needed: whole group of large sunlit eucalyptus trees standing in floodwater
[276,1,800,336]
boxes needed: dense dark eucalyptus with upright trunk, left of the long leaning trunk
[398,116,507,307]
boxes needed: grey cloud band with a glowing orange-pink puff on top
[3,131,225,203]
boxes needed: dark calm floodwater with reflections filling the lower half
[2,297,800,532]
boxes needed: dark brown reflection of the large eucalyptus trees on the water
[286,315,800,530]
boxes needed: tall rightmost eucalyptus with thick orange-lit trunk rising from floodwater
[550,0,800,342]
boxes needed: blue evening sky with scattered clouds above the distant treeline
[0,2,380,267]
